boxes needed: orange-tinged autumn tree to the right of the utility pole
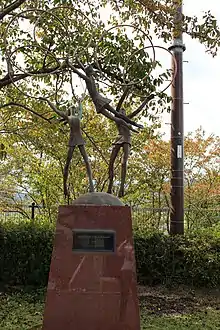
[185,127,220,230]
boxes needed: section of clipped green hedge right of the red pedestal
[135,228,220,287]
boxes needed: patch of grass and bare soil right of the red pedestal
[139,287,220,330]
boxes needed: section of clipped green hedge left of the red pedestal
[0,222,54,285]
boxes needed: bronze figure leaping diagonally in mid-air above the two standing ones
[67,62,143,132]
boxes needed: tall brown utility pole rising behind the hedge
[169,0,186,235]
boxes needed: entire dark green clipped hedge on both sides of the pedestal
[0,223,220,287]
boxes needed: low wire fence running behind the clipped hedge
[0,203,220,232]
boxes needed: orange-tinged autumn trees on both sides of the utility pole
[126,128,220,231]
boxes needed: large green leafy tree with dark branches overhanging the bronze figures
[0,0,219,222]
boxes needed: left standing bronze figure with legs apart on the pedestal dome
[40,97,94,198]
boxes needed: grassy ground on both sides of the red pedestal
[0,287,220,330]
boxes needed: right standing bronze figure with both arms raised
[107,89,154,197]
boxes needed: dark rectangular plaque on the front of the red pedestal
[73,229,115,252]
